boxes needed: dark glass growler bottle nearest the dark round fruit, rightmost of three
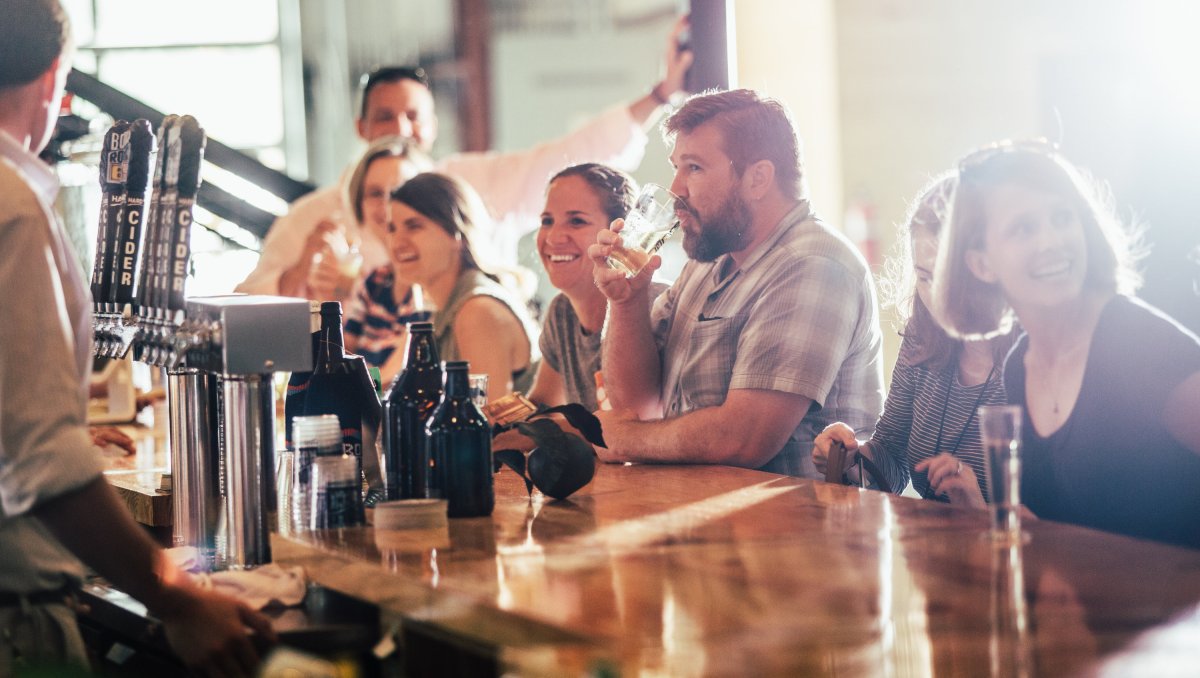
[425,361,496,518]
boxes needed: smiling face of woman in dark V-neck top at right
[966,184,1087,307]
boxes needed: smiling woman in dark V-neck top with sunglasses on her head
[934,142,1200,547]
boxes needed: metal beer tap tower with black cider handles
[91,115,312,569]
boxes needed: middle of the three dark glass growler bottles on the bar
[383,323,442,499]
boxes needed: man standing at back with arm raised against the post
[238,19,691,300]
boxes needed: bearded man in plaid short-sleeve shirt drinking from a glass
[588,90,883,478]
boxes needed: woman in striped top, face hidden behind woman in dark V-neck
[812,173,1012,506]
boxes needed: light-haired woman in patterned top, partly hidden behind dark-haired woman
[344,137,430,383]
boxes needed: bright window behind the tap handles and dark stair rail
[62,0,287,295]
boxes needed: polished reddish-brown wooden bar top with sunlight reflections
[274,466,1200,676]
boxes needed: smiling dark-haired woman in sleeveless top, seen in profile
[385,172,538,400]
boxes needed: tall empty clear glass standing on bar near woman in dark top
[979,404,1021,545]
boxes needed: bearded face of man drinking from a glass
[671,124,751,262]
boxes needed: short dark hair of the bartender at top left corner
[0,0,71,88]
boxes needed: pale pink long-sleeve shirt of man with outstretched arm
[238,106,647,294]
